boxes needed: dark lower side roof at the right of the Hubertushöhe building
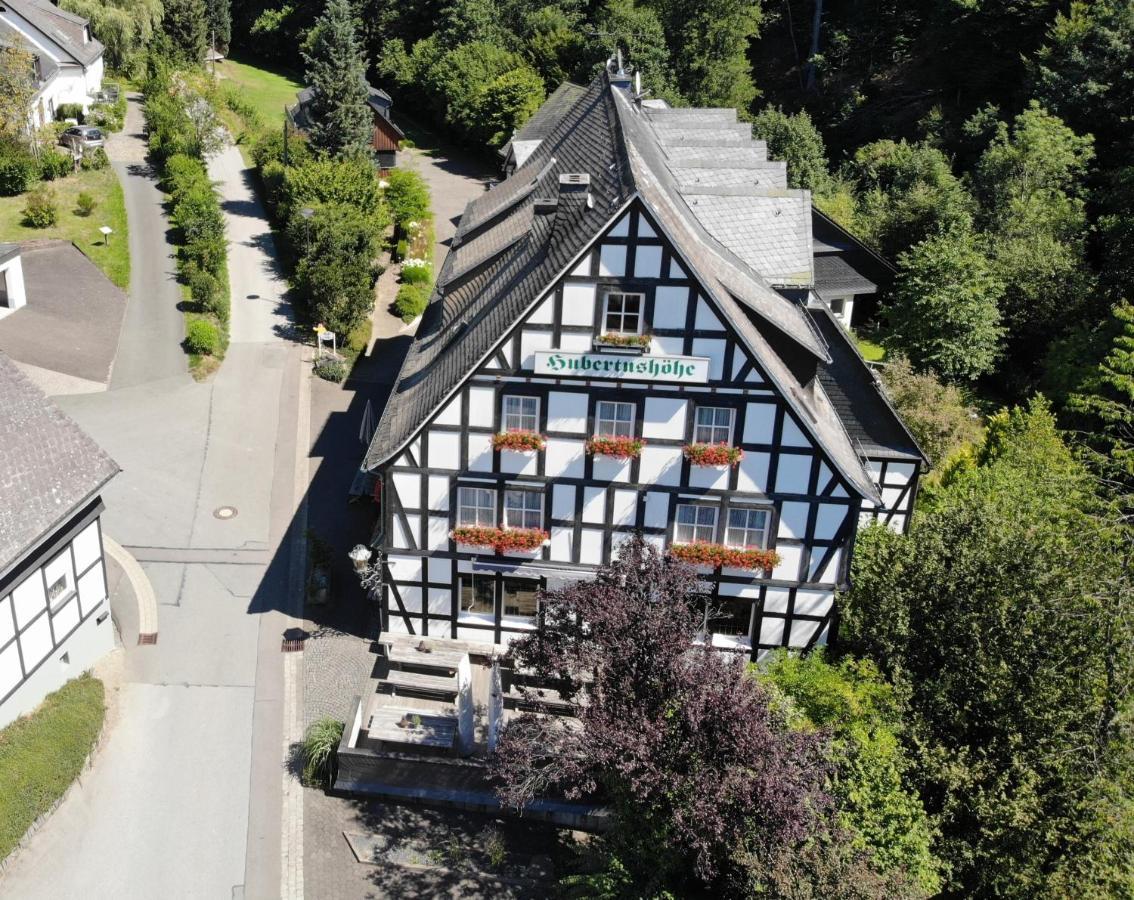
[807,307,924,462]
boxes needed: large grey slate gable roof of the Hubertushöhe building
[363,73,875,498]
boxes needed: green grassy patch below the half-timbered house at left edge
[0,674,105,859]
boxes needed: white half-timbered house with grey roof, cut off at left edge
[0,354,119,728]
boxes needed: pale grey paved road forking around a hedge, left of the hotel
[0,133,308,900]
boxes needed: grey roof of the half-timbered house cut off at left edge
[0,354,119,575]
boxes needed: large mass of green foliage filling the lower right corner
[844,402,1134,898]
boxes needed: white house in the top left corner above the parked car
[0,0,103,128]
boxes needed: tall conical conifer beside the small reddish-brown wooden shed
[303,0,373,156]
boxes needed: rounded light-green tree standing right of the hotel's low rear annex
[885,229,1004,381]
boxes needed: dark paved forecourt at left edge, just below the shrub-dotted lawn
[0,240,126,394]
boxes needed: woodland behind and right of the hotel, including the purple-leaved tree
[210,0,1134,898]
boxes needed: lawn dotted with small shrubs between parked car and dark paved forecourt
[0,165,130,290]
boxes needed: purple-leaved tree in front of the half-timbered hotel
[496,538,831,894]
